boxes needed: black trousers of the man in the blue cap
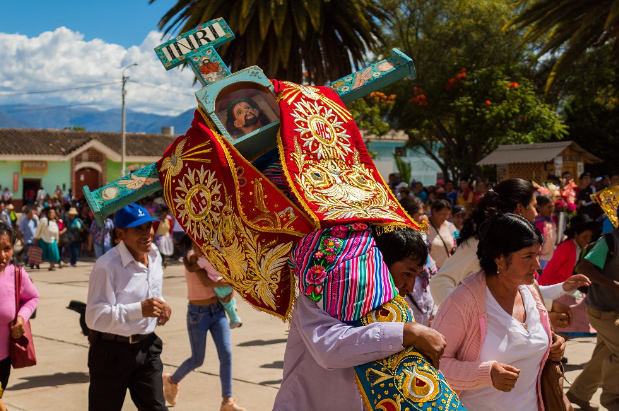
[88,334,168,411]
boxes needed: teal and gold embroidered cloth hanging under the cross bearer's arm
[354,296,465,411]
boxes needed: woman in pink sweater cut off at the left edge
[0,222,39,411]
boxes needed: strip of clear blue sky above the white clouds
[0,0,176,48]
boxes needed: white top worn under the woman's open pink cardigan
[460,285,550,411]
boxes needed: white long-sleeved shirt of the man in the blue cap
[86,241,163,337]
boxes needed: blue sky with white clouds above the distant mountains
[0,0,200,115]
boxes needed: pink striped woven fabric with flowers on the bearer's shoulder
[290,223,398,322]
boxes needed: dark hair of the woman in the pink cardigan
[477,213,544,276]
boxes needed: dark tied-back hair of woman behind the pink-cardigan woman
[458,178,535,244]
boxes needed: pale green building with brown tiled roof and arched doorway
[0,129,176,209]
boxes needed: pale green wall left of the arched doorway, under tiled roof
[0,160,71,199]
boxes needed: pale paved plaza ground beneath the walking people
[4,262,600,411]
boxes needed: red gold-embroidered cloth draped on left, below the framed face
[157,111,316,319]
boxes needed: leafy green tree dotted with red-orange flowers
[372,0,566,178]
